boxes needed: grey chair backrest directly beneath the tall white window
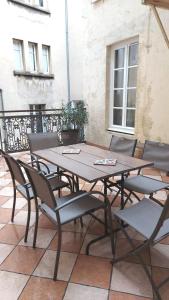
[109,135,137,156]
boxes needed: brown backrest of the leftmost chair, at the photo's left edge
[1,150,26,185]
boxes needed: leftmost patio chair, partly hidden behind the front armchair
[1,150,72,242]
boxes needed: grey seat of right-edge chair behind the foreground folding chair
[124,175,169,194]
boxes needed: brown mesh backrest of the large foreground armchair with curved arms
[20,161,56,208]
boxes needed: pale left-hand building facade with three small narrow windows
[0,0,84,110]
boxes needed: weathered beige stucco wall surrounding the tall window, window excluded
[83,0,169,146]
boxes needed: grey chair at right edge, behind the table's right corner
[119,140,169,206]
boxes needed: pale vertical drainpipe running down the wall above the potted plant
[65,0,70,102]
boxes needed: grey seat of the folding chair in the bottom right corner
[114,198,169,240]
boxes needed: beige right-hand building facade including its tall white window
[83,0,169,146]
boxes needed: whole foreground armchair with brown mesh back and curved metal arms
[19,163,114,280]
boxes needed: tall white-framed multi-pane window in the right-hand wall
[110,41,138,133]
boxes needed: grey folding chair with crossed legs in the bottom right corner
[112,195,169,300]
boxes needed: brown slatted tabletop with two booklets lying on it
[33,143,153,182]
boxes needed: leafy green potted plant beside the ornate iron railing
[61,101,88,144]
